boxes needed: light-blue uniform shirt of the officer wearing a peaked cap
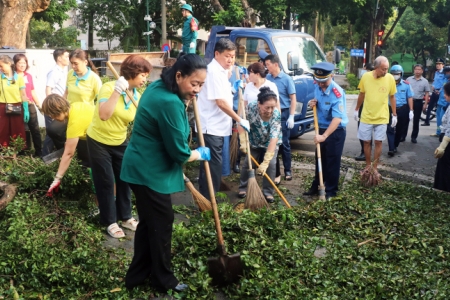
[314,81,348,129]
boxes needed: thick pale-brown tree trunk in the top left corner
[0,0,50,49]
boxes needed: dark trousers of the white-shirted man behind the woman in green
[198,134,223,201]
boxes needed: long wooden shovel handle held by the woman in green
[192,99,226,250]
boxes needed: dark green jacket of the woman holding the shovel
[120,79,191,194]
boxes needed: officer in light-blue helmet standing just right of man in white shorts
[386,65,414,157]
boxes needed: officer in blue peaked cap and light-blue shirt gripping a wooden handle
[303,62,348,199]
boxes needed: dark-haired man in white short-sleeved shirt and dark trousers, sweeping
[197,38,250,199]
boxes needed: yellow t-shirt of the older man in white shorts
[358,71,397,125]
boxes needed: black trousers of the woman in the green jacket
[125,184,178,292]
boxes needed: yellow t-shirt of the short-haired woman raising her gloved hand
[87,81,141,146]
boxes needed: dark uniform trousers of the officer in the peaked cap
[311,128,346,197]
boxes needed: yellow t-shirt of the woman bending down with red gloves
[66,102,95,140]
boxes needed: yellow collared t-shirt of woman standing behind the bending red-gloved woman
[67,68,102,106]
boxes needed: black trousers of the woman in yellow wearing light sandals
[86,136,132,226]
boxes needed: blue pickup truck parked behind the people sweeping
[205,26,326,138]
